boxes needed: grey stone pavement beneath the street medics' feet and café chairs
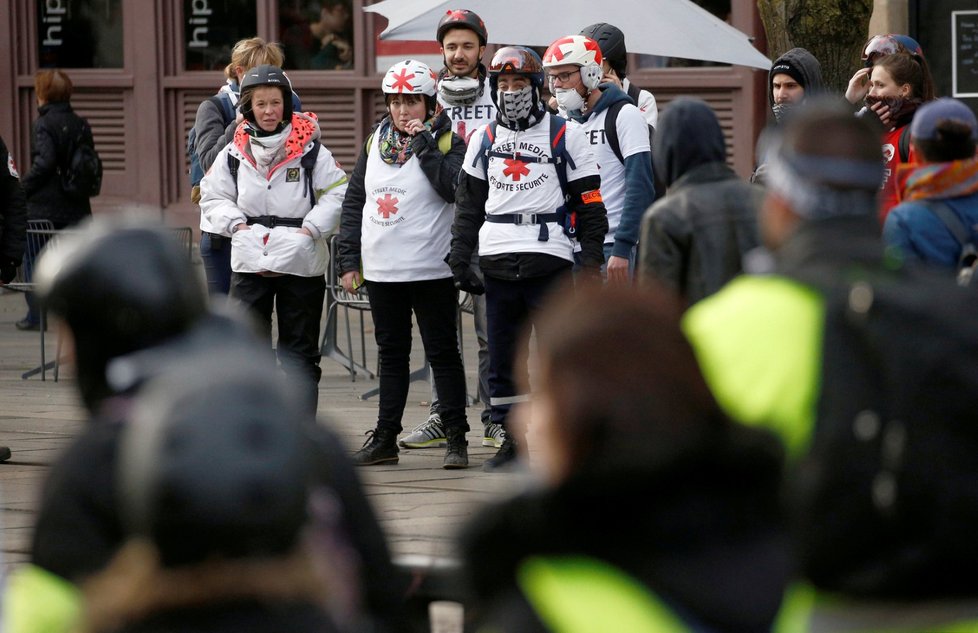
[0,290,526,571]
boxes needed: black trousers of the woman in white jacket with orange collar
[230,273,326,413]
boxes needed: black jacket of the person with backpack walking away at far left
[22,102,94,229]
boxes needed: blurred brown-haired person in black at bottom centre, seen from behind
[462,288,789,633]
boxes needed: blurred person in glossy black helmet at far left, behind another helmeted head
[3,219,402,633]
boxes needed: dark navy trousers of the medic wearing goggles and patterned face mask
[484,267,570,427]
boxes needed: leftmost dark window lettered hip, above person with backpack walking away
[37,0,123,68]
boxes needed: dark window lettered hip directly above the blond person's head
[183,0,258,70]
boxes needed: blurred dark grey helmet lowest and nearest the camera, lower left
[117,356,312,567]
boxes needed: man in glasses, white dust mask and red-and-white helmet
[543,35,655,282]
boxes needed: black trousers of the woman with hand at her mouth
[367,278,469,433]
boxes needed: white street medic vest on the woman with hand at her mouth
[360,134,453,282]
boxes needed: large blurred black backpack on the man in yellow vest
[785,269,978,599]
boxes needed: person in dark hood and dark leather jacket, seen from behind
[639,97,762,305]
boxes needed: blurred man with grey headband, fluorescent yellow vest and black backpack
[683,104,978,632]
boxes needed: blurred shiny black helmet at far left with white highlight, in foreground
[34,219,207,411]
